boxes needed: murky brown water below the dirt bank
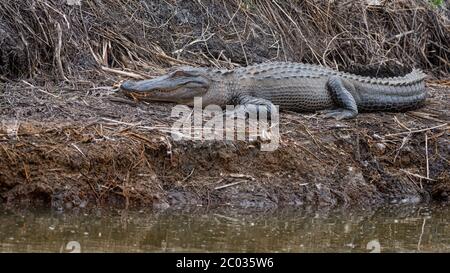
[0,206,450,252]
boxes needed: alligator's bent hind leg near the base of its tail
[322,76,358,120]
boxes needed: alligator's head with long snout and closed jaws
[120,67,211,105]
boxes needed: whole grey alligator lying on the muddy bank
[120,62,426,120]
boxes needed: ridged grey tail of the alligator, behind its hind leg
[344,69,427,111]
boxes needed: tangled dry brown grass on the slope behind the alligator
[0,0,450,81]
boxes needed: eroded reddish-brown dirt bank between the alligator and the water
[0,82,450,209]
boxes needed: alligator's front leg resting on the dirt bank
[226,95,278,119]
